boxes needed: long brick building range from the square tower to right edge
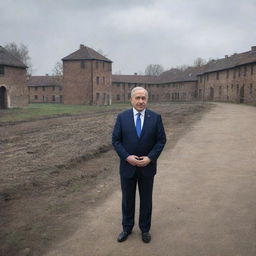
[112,46,256,103]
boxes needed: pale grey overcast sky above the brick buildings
[0,0,256,75]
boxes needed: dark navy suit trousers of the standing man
[121,168,154,233]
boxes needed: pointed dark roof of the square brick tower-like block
[62,44,112,62]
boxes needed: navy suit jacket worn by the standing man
[112,109,166,178]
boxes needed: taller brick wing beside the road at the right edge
[198,46,256,103]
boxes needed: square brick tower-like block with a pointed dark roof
[62,44,112,105]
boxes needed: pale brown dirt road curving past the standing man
[46,104,256,256]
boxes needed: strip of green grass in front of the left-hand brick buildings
[0,103,129,123]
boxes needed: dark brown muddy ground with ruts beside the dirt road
[0,103,212,256]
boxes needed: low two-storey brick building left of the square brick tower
[27,75,63,103]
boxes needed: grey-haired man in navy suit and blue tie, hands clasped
[112,87,166,243]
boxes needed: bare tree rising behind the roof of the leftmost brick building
[4,42,33,75]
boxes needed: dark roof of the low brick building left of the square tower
[27,75,63,87]
